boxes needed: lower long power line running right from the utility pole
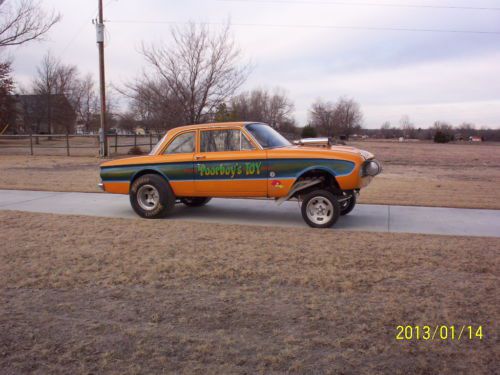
[108,20,500,35]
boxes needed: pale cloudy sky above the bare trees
[9,0,500,128]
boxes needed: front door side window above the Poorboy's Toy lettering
[200,129,253,152]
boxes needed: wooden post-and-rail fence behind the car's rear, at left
[0,134,162,156]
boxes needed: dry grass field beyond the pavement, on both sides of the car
[0,141,500,209]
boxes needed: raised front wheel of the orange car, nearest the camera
[301,190,340,228]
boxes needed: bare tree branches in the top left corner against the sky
[0,0,61,47]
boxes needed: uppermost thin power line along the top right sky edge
[216,0,500,11]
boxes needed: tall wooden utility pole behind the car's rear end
[96,0,108,157]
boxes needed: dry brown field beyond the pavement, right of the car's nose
[352,141,500,209]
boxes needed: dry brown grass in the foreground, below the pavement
[0,212,500,374]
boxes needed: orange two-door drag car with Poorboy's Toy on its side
[100,122,381,228]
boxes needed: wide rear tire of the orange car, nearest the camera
[129,174,175,219]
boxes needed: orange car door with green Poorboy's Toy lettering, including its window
[194,128,267,197]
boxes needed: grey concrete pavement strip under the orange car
[0,190,500,237]
